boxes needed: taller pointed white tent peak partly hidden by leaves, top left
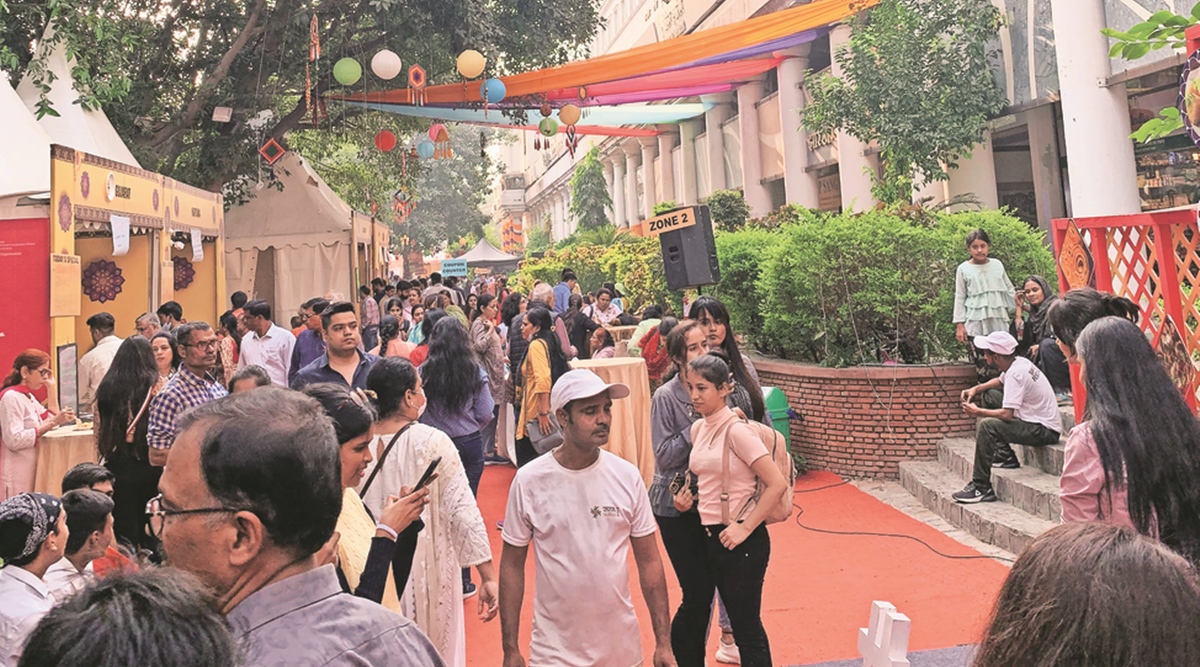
[16,28,140,169]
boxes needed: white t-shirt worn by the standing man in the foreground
[503,450,658,667]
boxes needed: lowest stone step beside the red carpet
[900,461,1055,554]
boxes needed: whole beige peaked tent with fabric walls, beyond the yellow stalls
[226,151,354,316]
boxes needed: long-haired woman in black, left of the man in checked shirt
[96,336,162,551]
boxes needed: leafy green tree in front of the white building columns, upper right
[803,0,1007,203]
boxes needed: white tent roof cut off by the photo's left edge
[0,76,50,197]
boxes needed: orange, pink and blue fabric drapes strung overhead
[331,0,878,134]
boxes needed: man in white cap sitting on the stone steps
[954,331,1062,503]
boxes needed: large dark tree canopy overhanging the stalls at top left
[0,0,599,198]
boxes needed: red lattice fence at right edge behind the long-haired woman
[1052,208,1200,420]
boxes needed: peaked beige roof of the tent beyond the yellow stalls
[226,151,352,250]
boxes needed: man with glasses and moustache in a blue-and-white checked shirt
[146,322,228,465]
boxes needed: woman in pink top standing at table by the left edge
[0,349,74,500]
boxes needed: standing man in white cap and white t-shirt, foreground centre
[500,369,676,667]
